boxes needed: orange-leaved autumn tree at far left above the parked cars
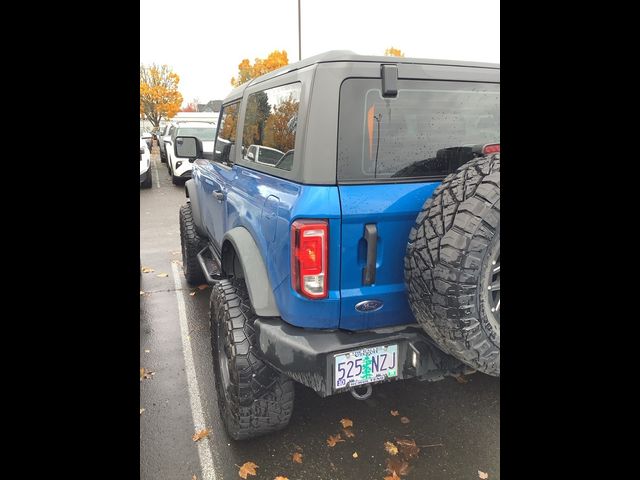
[140,64,182,128]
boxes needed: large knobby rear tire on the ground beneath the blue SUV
[210,279,294,440]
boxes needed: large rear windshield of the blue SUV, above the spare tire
[338,78,500,183]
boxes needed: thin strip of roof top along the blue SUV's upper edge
[227,50,500,97]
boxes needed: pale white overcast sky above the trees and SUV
[140,0,500,103]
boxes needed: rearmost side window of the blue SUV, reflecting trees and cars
[242,82,302,171]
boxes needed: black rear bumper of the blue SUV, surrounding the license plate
[254,318,471,397]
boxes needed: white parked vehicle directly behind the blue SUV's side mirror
[165,122,216,185]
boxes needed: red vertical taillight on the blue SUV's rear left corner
[291,220,329,299]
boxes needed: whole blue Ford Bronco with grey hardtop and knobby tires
[173,51,500,439]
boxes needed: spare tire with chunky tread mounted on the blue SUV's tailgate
[404,154,500,376]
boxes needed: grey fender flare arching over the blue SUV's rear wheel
[222,227,280,317]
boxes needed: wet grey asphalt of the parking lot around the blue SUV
[140,144,500,480]
